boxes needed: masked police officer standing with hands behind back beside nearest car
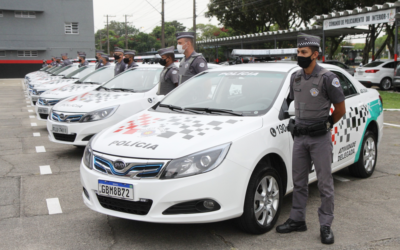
[276,33,346,244]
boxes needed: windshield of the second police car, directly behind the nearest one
[103,67,162,92]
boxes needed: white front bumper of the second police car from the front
[47,114,122,146]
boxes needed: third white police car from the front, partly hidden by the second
[35,65,115,120]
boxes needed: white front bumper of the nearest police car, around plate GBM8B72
[80,159,250,223]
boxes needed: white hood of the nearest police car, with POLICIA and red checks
[92,110,262,159]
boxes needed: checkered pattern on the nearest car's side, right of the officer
[331,105,370,145]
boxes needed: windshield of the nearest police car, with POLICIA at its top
[157,71,287,116]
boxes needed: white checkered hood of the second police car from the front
[54,90,144,113]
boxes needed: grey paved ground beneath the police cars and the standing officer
[0,80,400,250]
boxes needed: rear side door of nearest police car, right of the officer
[331,70,360,169]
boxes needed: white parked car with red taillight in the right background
[354,61,397,90]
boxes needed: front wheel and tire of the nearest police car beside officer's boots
[236,162,283,234]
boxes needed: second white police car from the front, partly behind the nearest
[43,64,163,146]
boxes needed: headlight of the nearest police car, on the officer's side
[161,143,231,179]
